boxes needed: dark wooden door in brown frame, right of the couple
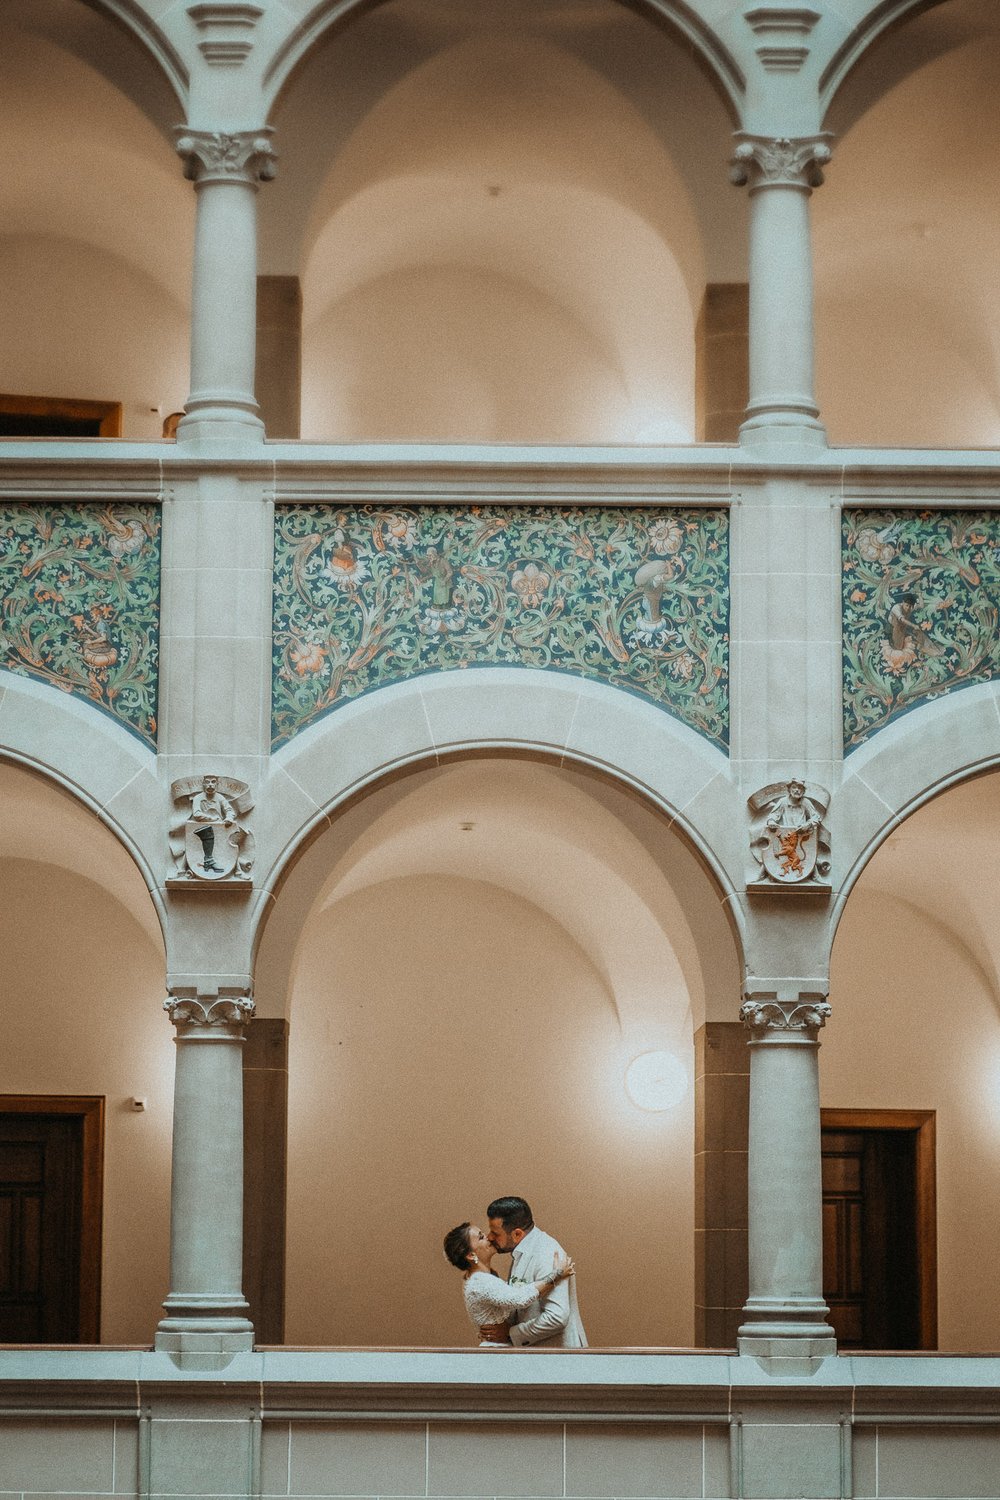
[823,1110,937,1349]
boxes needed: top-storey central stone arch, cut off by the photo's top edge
[264,0,745,126]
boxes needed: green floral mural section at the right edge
[844,510,1000,752]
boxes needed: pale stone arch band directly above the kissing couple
[253,669,745,1008]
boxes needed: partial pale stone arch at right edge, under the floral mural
[829,683,1000,942]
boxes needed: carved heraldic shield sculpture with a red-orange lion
[747,779,831,894]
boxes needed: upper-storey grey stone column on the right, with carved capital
[730,135,831,446]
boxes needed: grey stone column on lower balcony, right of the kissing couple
[739,980,837,1359]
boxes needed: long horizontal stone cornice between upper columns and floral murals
[0,440,1000,509]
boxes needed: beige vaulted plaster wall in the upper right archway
[813,0,1000,447]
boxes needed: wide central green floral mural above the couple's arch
[273,506,729,749]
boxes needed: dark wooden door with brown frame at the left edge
[0,1095,103,1344]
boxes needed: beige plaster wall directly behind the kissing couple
[286,876,694,1346]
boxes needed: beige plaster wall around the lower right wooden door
[820,840,1000,1352]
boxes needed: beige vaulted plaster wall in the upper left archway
[0,16,195,438]
